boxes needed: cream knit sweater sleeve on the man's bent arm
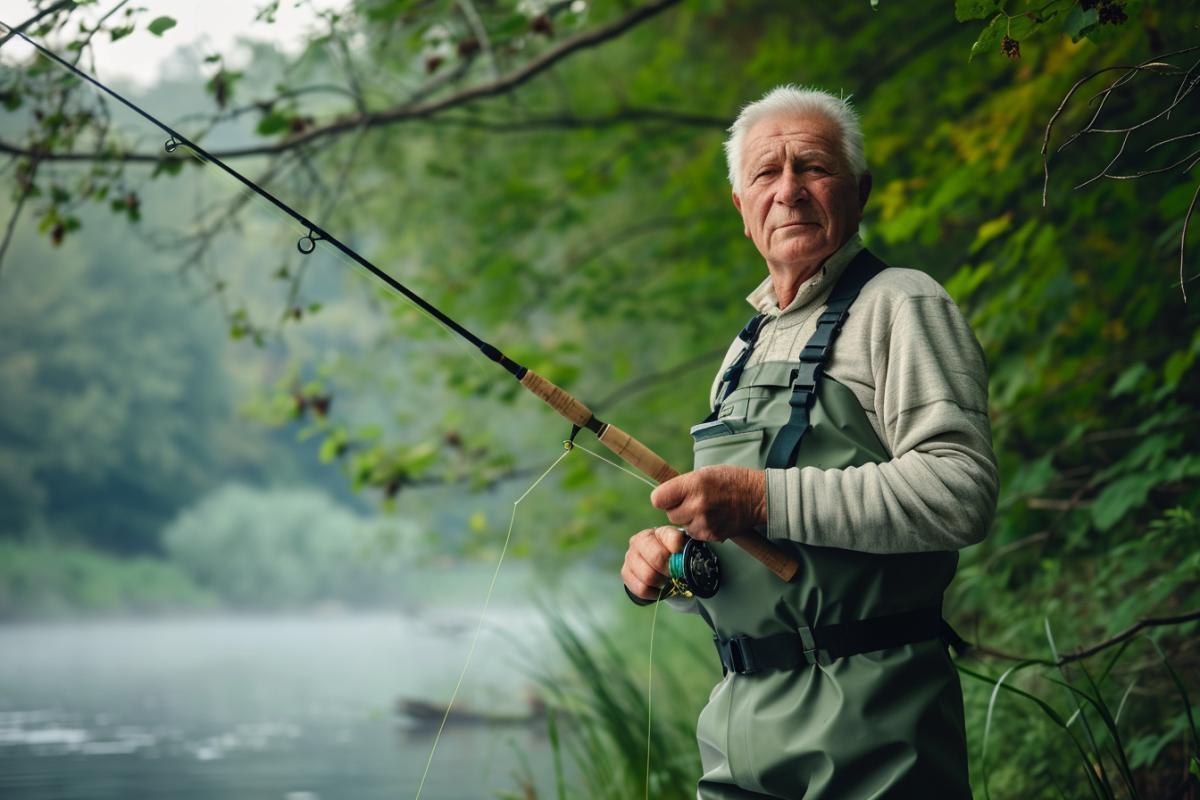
[767,292,998,553]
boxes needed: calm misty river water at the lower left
[0,610,552,800]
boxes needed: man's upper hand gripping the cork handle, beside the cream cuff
[650,464,767,542]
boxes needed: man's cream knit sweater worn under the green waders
[710,234,998,553]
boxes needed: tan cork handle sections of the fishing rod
[521,371,800,581]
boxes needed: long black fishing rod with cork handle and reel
[0,23,799,597]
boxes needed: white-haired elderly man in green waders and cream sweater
[622,86,997,800]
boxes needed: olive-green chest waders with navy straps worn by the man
[692,249,971,800]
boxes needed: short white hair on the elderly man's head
[725,84,866,192]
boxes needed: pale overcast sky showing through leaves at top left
[0,0,344,86]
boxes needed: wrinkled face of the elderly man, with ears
[733,115,870,271]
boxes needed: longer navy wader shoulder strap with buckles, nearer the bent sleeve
[767,248,887,469]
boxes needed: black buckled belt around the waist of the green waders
[713,607,966,675]
